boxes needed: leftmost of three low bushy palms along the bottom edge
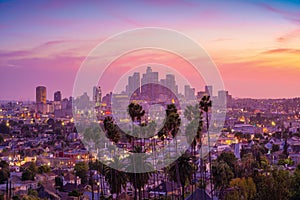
[104,156,127,199]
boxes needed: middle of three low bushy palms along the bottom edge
[126,146,153,199]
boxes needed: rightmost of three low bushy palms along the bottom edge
[168,153,196,200]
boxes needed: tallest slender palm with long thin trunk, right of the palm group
[199,95,213,198]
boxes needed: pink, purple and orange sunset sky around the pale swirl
[0,0,300,100]
